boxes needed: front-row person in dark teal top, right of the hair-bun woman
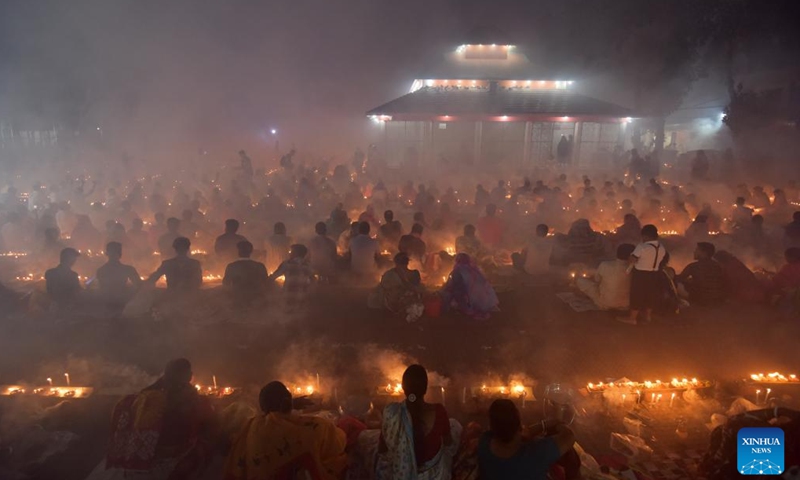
[478,398,581,480]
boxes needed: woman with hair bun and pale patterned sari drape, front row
[376,365,461,480]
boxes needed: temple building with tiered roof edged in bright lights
[367,44,633,168]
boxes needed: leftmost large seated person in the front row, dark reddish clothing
[106,358,218,480]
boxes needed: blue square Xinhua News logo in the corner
[736,427,784,475]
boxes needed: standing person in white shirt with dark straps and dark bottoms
[617,225,669,325]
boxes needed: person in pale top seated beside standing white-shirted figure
[575,243,636,310]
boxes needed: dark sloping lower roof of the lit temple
[367,87,632,118]
